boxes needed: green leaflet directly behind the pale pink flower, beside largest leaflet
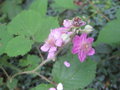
[34,17,59,42]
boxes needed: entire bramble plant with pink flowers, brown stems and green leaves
[0,0,120,90]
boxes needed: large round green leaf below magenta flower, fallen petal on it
[52,54,96,90]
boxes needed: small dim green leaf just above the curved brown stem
[19,55,41,70]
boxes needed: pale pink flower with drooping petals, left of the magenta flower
[41,27,71,59]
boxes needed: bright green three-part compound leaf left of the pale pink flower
[6,10,58,56]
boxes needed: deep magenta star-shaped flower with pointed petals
[72,33,95,62]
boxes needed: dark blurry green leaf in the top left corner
[1,0,22,19]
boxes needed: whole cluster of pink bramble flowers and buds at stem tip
[41,17,95,62]
